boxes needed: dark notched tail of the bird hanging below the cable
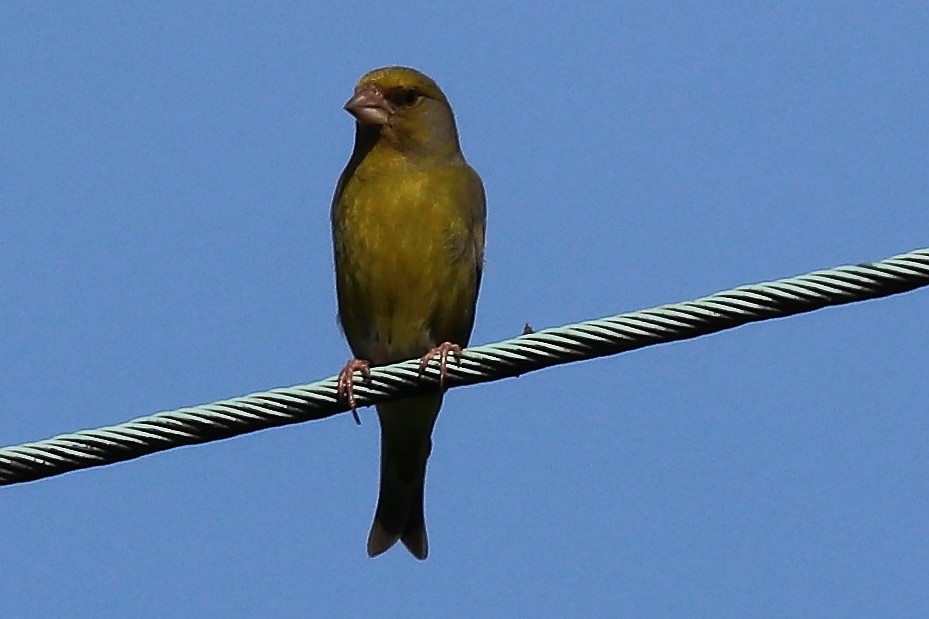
[368,394,442,559]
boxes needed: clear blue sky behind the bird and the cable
[0,2,929,619]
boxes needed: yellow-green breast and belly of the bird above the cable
[333,167,477,363]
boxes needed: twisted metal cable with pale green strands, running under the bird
[0,248,929,485]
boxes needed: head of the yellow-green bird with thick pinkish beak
[345,67,461,159]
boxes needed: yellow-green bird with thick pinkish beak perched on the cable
[332,67,486,559]
